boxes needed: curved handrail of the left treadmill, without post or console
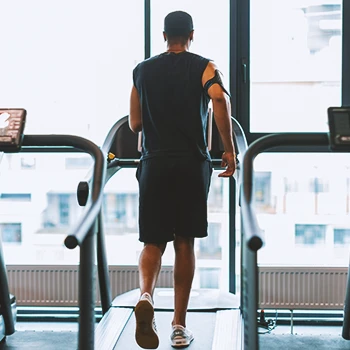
[22,134,106,249]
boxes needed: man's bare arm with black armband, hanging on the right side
[202,62,236,177]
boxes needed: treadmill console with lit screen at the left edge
[0,108,27,153]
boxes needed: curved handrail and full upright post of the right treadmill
[241,133,328,350]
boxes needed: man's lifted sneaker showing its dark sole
[135,293,159,349]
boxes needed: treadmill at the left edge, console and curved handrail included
[0,108,106,349]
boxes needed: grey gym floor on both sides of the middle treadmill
[0,322,350,350]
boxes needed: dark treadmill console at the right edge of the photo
[328,107,350,152]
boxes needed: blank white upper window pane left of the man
[0,0,144,143]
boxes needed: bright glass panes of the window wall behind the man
[0,0,350,296]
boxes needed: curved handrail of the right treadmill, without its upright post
[241,133,329,251]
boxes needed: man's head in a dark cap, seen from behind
[163,11,193,45]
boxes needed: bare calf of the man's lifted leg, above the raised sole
[139,243,166,296]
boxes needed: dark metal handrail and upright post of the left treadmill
[0,135,107,349]
